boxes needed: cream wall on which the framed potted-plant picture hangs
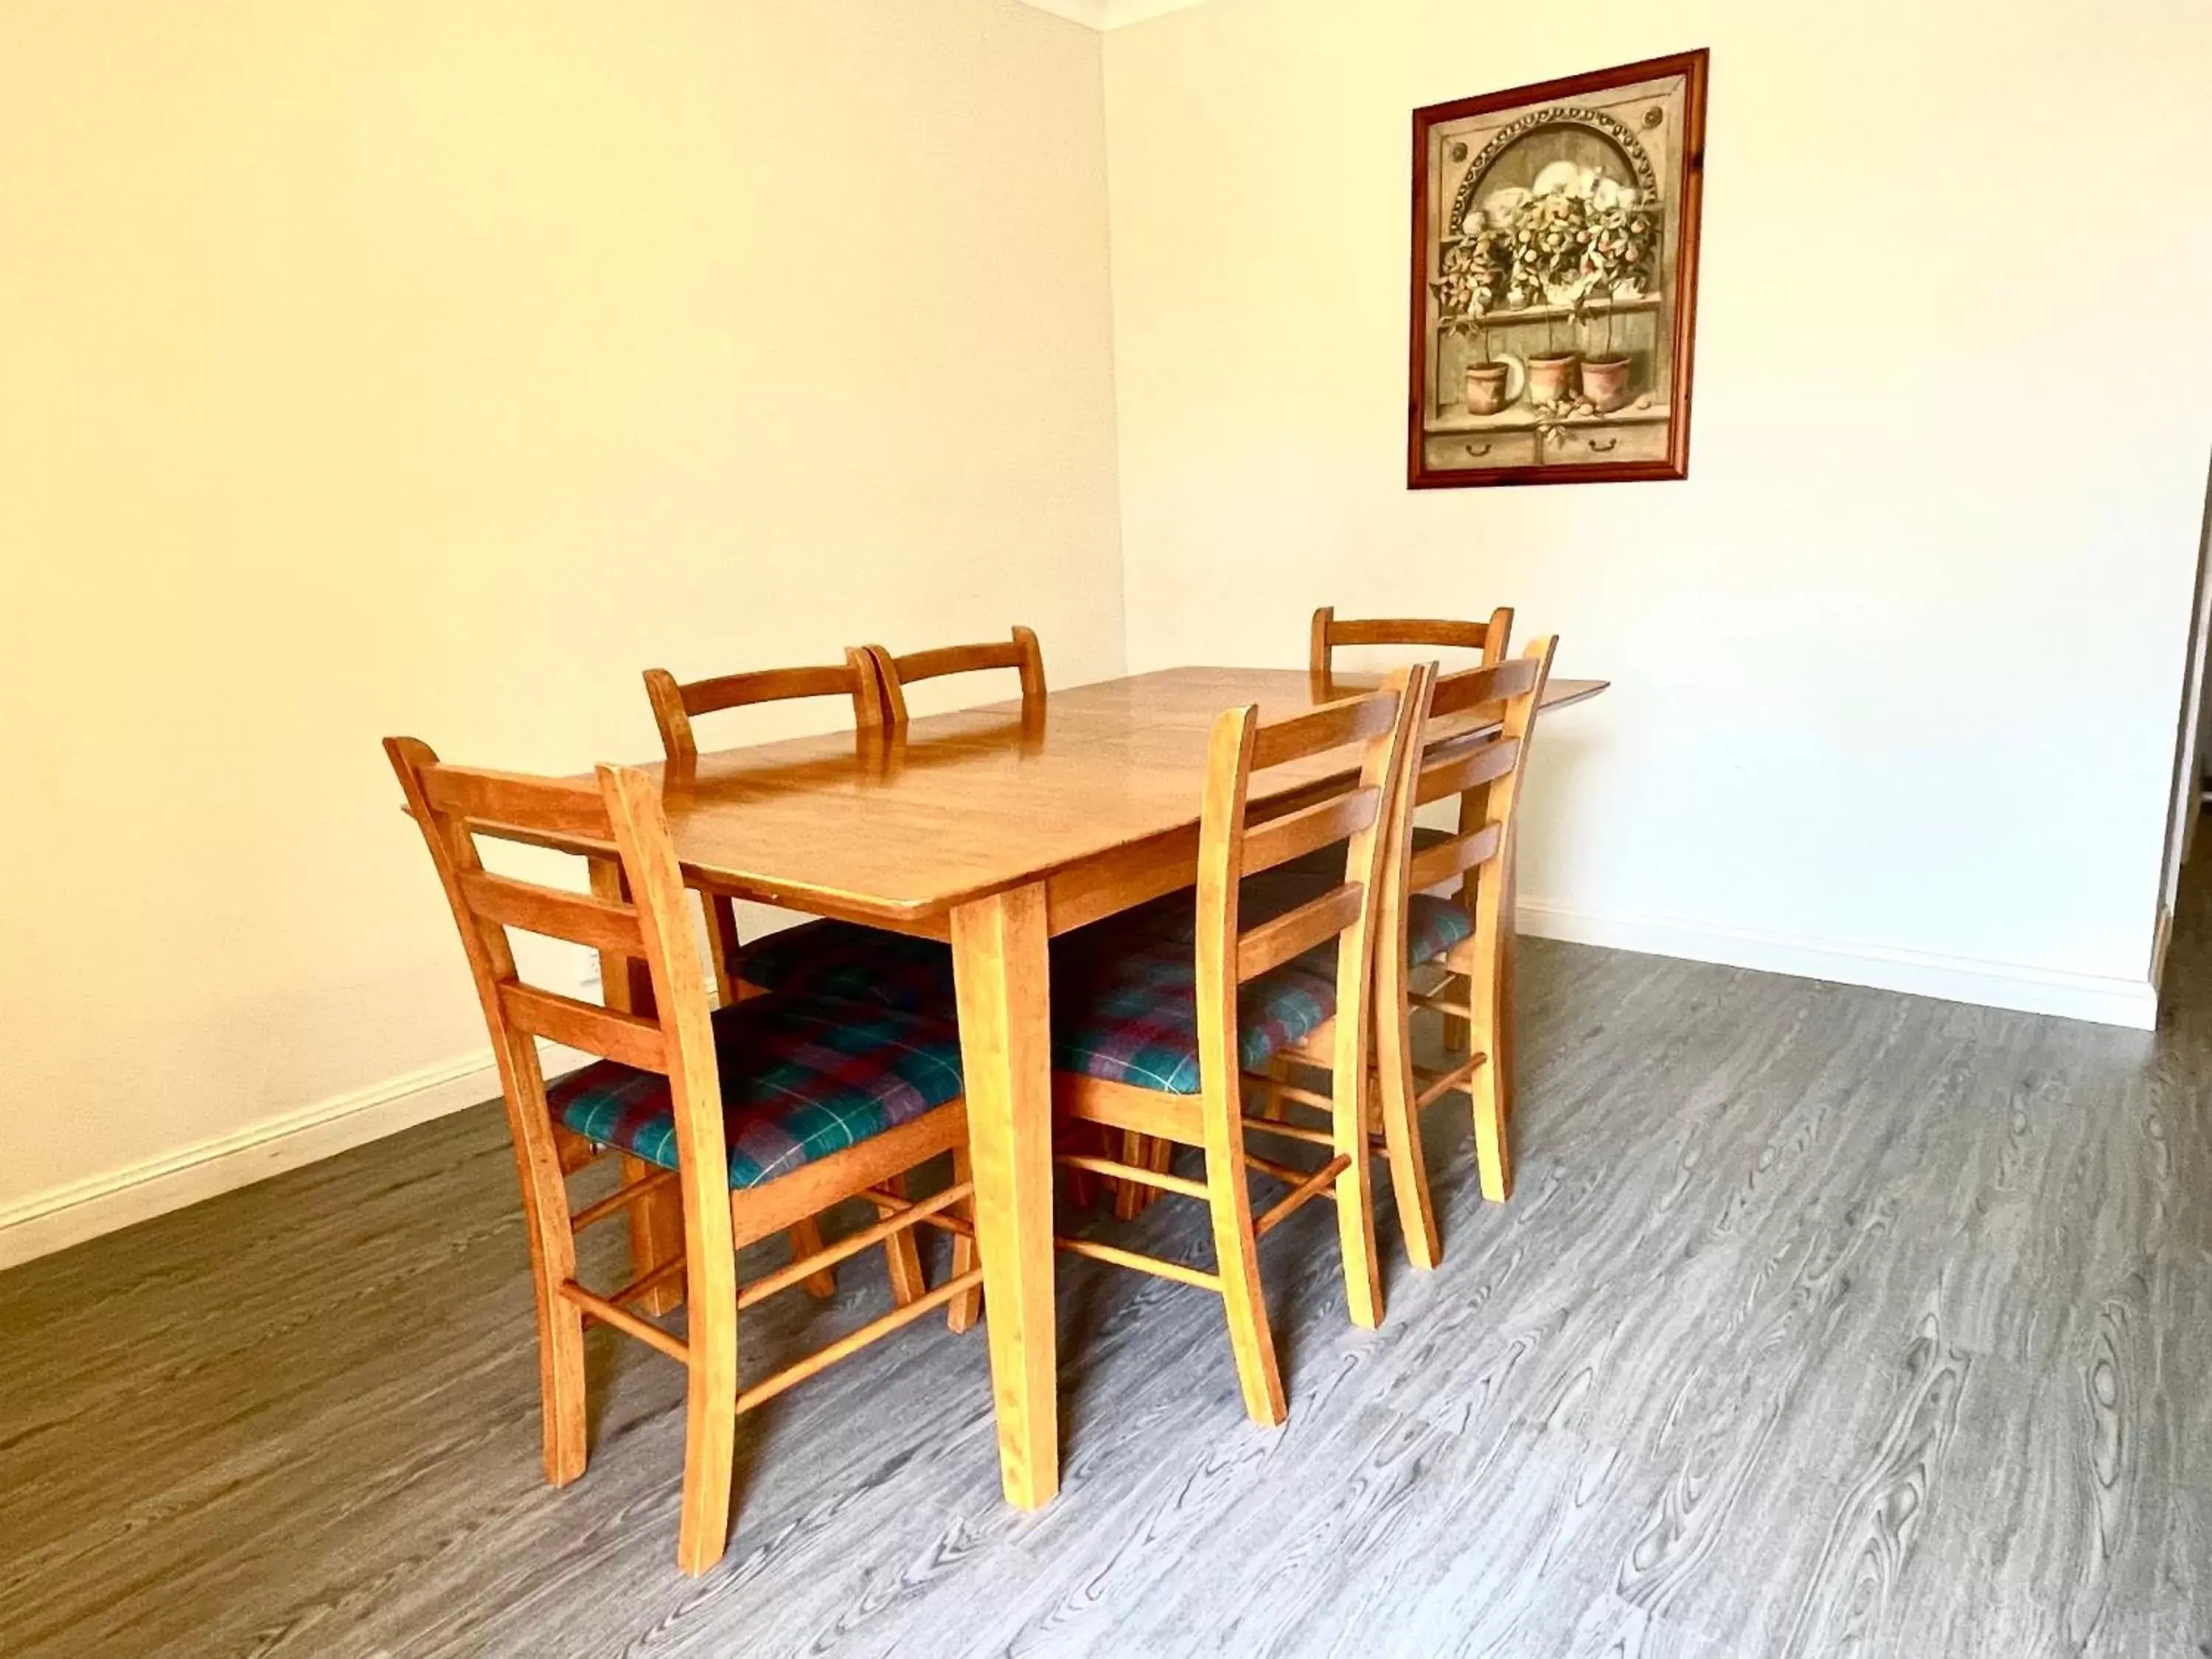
[1106,0,2212,1022]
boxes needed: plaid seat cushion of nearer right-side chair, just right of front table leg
[1053,942,1336,1095]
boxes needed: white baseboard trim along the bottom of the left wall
[0,1044,588,1267]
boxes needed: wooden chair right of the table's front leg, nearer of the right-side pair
[1053,666,1429,1425]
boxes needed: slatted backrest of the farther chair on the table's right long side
[1376,635,1559,998]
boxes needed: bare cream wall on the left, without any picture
[0,0,1124,1230]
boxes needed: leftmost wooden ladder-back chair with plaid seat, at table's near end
[385,739,982,1573]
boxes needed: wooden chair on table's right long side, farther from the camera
[1374,637,1557,1267]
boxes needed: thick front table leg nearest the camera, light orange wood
[953,885,1060,1509]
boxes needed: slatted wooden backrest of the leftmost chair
[385,737,730,1243]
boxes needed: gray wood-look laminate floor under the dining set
[0,894,2212,1659]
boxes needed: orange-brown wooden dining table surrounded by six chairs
[633,668,1606,1509]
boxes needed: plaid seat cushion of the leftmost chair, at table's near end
[546,995,960,1188]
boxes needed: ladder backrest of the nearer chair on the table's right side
[1197,664,1433,1113]
